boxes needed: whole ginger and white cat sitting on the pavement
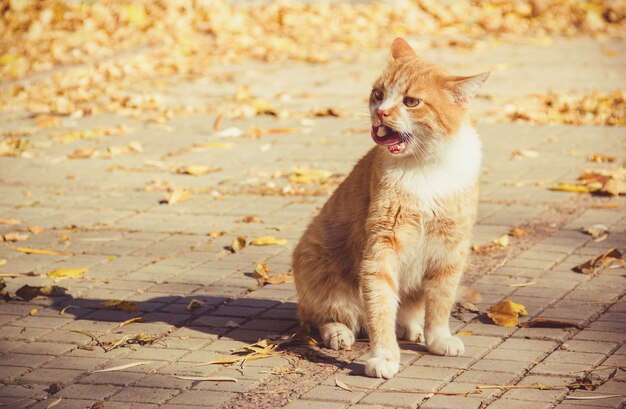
[293,38,489,378]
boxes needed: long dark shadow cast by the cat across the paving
[34,295,364,374]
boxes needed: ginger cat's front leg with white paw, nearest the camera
[361,248,400,378]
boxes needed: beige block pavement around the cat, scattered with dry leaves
[0,35,626,409]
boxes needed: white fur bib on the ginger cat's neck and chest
[385,125,482,211]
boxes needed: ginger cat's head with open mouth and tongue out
[370,38,489,157]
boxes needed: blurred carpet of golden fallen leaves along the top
[0,0,626,127]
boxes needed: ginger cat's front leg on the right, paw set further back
[423,263,465,356]
